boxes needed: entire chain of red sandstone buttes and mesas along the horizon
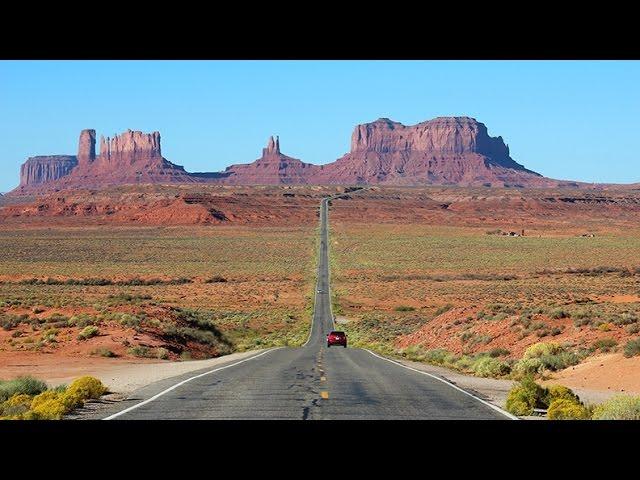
[12,117,564,194]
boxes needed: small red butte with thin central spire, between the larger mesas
[218,137,321,185]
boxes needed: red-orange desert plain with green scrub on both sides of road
[0,184,640,393]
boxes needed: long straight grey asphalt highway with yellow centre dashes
[101,198,508,420]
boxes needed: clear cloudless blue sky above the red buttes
[0,61,640,192]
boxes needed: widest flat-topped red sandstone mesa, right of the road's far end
[317,117,557,186]
